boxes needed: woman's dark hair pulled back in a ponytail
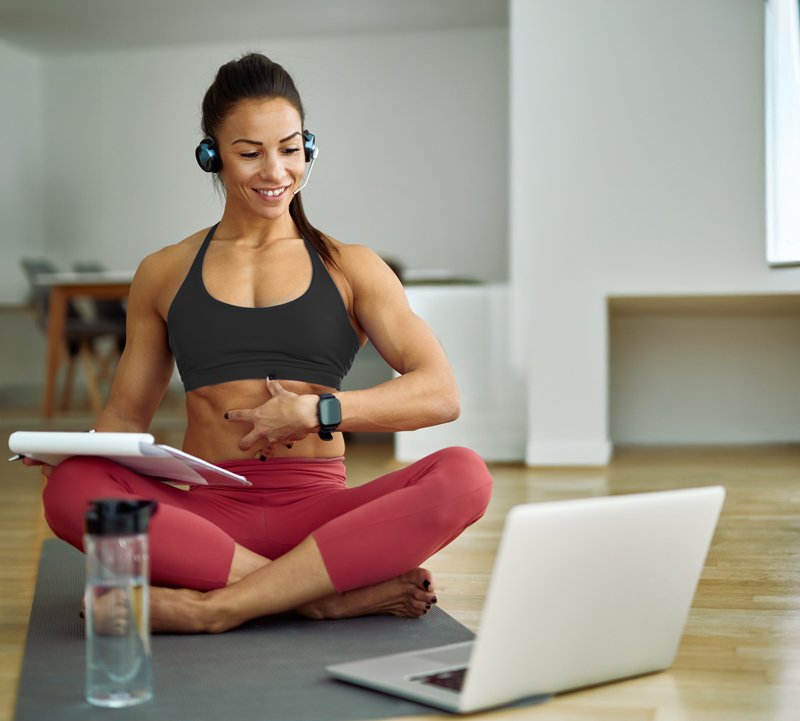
[202,53,336,266]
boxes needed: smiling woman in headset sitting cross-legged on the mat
[29,54,491,632]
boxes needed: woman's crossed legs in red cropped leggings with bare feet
[45,449,491,632]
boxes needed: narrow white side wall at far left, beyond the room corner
[0,42,45,303]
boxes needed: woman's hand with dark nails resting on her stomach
[225,379,319,458]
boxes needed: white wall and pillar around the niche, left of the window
[510,0,800,464]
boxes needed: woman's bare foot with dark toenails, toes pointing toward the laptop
[296,568,437,620]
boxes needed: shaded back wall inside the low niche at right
[609,315,800,445]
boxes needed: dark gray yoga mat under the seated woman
[15,540,473,721]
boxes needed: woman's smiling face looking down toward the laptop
[217,98,305,220]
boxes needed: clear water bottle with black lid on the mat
[83,498,157,708]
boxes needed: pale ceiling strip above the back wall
[0,0,508,53]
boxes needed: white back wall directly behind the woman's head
[37,28,508,281]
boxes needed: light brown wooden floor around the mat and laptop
[0,419,800,721]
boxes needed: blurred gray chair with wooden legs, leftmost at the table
[20,258,125,415]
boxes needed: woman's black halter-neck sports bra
[167,223,361,393]
